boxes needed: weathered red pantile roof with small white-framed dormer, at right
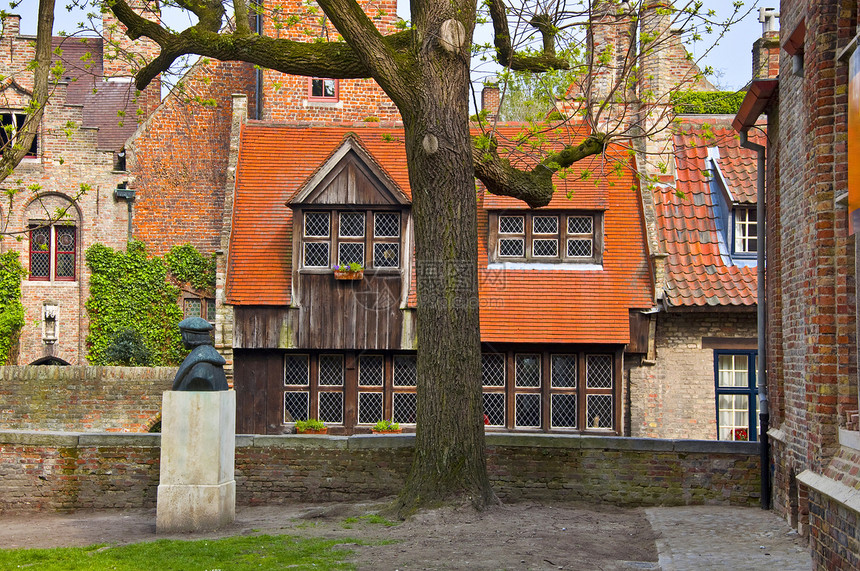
[654,127,763,307]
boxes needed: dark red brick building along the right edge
[735,0,860,569]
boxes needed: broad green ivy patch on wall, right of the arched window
[86,241,187,365]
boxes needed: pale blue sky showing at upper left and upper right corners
[13,0,764,89]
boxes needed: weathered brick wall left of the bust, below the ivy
[0,366,176,432]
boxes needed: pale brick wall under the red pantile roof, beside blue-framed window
[628,312,756,440]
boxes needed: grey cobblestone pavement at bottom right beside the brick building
[645,506,812,571]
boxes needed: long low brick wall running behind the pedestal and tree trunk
[0,430,759,511]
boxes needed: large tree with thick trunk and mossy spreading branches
[102,0,744,514]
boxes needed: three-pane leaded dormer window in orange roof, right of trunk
[490,212,602,263]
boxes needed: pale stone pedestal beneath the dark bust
[155,391,236,533]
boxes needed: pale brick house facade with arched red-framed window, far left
[0,15,159,364]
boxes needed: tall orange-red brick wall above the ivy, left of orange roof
[128,61,254,255]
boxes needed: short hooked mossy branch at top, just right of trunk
[489,0,570,73]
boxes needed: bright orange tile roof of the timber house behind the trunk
[227,122,653,343]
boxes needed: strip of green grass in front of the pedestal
[0,535,362,571]
